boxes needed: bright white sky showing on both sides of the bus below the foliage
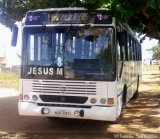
[0,24,158,67]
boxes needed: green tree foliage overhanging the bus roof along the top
[0,0,160,40]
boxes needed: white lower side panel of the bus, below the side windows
[117,58,141,103]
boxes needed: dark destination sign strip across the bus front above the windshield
[25,11,112,25]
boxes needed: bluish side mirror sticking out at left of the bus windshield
[11,25,18,46]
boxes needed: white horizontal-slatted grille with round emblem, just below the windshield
[33,80,96,95]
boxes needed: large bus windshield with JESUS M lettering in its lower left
[21,26,115,81]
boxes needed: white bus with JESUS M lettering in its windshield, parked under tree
[12,8,141,122]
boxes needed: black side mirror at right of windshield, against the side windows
[117,32,127,46]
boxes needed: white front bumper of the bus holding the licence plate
[18,101,118,121]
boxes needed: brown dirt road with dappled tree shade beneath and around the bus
[0,72,160,139]
